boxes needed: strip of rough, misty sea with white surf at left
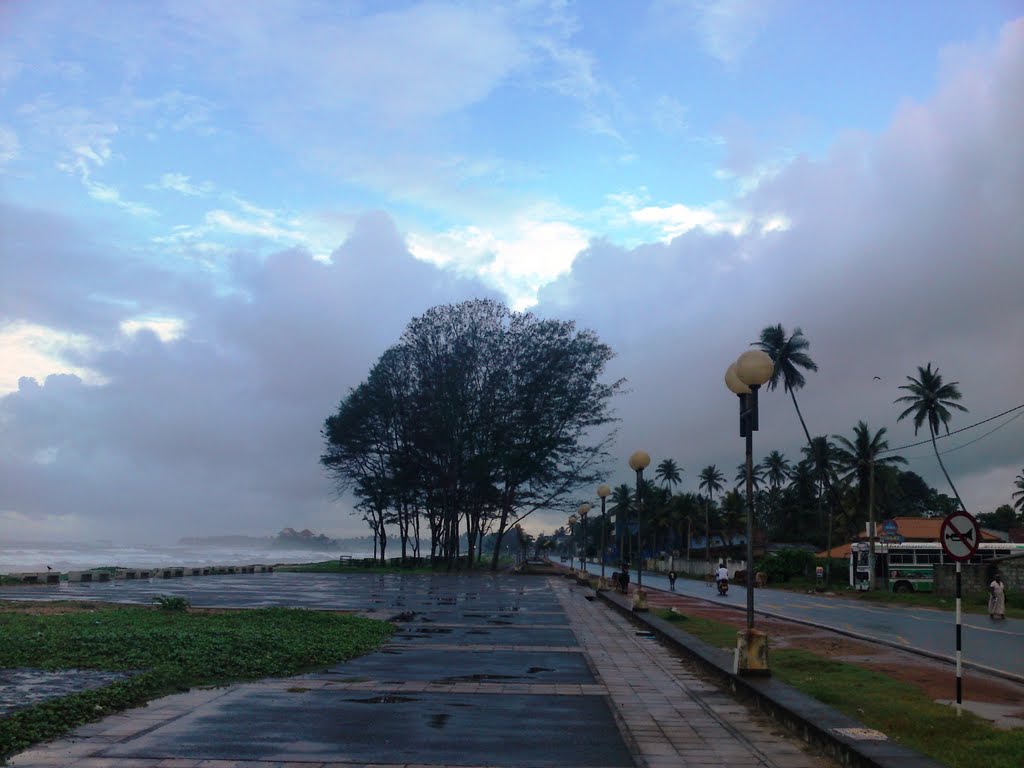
[0,542,373,573]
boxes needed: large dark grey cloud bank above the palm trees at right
[542,22,1024,528]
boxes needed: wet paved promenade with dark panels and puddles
[11,573,836,768]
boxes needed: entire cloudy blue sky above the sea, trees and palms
[0,0,1024,544]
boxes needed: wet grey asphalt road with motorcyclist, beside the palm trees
[587,563,1024,682]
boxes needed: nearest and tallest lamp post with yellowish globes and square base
[725,349,774,673]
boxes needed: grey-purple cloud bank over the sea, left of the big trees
[0,207,495,541]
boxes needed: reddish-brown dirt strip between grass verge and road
[647,590,1024,705]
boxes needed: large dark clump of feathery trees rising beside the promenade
[321,300,622,567]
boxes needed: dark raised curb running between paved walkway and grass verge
[597,592,942,768]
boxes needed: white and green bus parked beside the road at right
[850,542,1024,592]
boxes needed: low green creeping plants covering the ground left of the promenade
[0,603,392,759]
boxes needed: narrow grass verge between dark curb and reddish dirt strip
[655,610,1024,768]
